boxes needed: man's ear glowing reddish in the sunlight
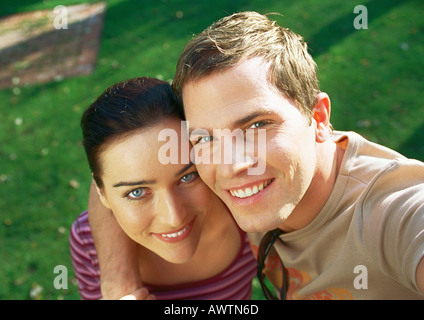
[312,92,331,142]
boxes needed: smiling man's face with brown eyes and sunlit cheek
[183,58,316,232]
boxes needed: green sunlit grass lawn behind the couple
[0,0,424,299]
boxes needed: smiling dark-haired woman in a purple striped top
[70,78,256,299]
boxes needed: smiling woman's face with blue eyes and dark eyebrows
[98,118,214,263]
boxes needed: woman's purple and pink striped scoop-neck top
[69,211,256,300]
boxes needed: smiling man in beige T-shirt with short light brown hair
[84,12,424,299]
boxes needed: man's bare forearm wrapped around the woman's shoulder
[88,181,144,299]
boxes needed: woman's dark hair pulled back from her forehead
[81,77,183,188]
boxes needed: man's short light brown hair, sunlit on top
[173,12,319,119]
